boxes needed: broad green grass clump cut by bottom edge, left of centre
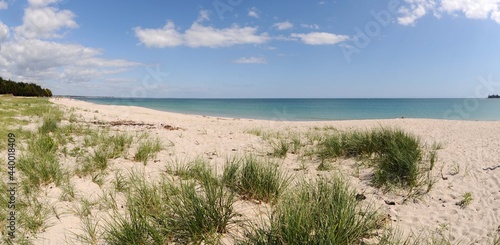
[104,168,237,244]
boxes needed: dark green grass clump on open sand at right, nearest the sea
[318,128,437,188]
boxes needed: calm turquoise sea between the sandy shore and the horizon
[76,97,500,121]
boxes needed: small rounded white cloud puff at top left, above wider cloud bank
[15,3,78,38]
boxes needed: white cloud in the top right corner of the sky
[398,0,500,25]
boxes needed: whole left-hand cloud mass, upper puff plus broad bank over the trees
[0,0,142,88]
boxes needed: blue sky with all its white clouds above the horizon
[0,0,500,98]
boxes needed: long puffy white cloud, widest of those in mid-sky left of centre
[134,21,269,48]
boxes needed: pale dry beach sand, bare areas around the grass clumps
[30,98,500,244]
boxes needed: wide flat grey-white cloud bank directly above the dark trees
[0,39,140,82]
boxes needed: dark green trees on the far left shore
[0,77,52,97]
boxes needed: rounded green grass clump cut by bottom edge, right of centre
[243,178,379,244]
